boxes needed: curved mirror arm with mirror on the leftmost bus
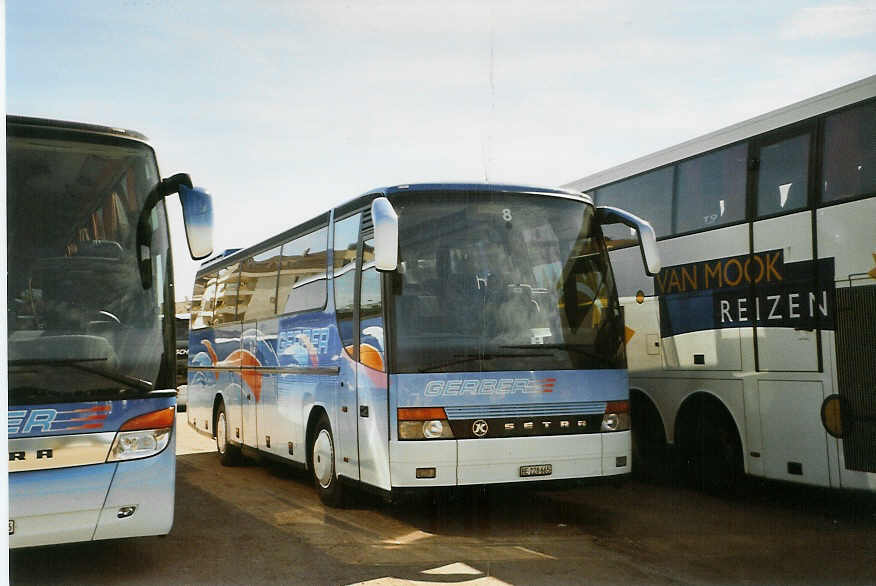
[136,173,213,289]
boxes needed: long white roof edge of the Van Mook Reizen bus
[563,75,876,191]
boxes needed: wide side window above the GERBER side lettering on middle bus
[277,228,328,313]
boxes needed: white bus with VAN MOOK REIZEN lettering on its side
[565,76,876,490]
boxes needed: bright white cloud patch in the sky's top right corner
[779,1,876,40]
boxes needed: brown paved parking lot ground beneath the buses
[10,416,876,586]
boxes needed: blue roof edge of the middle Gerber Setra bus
[197,183,593,276]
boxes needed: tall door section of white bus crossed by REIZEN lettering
[747,123,830,485]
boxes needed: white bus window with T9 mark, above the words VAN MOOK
[675,143,748,233]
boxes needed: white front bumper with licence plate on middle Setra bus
[389,431,631,488]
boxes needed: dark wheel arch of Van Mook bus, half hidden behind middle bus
[630,389,667,479]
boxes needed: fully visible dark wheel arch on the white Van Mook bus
[675,391,744,493]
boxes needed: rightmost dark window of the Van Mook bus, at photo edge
[821,103,876,202]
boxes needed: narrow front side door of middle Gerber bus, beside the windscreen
[356,238,390,490]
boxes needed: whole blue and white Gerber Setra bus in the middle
[187,184,659,504]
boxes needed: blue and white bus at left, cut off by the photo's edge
[6,116,212,548]
